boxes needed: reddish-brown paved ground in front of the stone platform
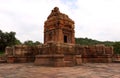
[0,63,120,78]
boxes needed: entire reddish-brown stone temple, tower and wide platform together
[5,7,114,67]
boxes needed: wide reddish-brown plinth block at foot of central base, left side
[35,55,64,66]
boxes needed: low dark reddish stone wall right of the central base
[82,45,114,63]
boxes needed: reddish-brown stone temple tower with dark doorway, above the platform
[44,7,75,44]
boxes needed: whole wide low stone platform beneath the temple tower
[5,43,114,66]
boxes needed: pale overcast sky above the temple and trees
[0,0,120,42]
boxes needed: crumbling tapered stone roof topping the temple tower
[44,7,74,29]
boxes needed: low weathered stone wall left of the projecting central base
[5,45,42,63]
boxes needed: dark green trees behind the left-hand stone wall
[0,30,41,52]
